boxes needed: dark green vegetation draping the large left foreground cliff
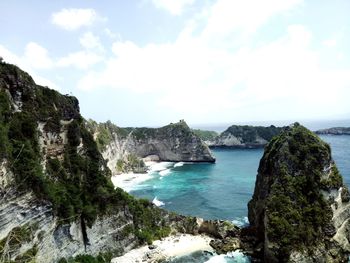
[0,63,174,262]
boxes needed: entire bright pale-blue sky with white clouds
[0,0,350,126]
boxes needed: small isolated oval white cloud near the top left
[51,8,99,31]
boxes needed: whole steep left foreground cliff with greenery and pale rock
[0,62,175,263]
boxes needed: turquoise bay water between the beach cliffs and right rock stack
[130,149,263,224]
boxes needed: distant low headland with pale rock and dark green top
[205,125,283,148]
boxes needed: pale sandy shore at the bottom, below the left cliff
[111,234,213,263]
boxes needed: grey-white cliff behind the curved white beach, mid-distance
[88,121,215,176]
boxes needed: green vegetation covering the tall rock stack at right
[259,124,342,262]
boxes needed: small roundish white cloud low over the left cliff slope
[25,42,53,69]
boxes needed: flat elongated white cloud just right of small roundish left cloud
[57,51,103,70]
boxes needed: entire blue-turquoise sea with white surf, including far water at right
[130,121,350,263]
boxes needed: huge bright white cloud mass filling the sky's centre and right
[78,0,350,123]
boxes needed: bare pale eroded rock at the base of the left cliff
[0,190,137,263]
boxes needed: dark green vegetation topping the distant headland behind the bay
[222,125,282,143]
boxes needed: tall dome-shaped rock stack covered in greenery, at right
[248,124,350,262]
